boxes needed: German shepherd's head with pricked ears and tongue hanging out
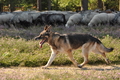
[35,26,51,48]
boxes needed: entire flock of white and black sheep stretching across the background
[0,10,120,28]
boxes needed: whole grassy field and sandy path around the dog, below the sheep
[0,26,120,80]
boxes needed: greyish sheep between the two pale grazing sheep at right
[81,11,99,25]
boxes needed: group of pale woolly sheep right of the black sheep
[65,10,120,28]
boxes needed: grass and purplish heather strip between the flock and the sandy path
[0,26,120,67]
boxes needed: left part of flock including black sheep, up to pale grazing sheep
[0,11,76,28]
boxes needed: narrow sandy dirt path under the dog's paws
[0,65,120,74]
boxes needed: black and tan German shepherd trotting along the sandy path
[35,26,113,68]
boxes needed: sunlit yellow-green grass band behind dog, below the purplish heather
[0,32,120,67]
